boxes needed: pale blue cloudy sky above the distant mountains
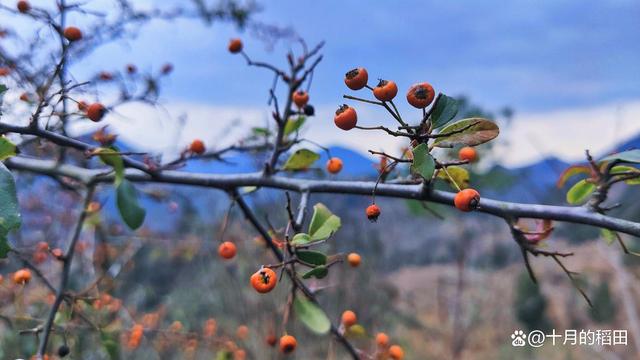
[5,0,640,163]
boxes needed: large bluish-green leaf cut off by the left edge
[0,163,21,258]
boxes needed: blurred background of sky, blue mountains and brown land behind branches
[0,0,640,359]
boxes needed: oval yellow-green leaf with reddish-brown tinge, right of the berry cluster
[433,118,500,148]
